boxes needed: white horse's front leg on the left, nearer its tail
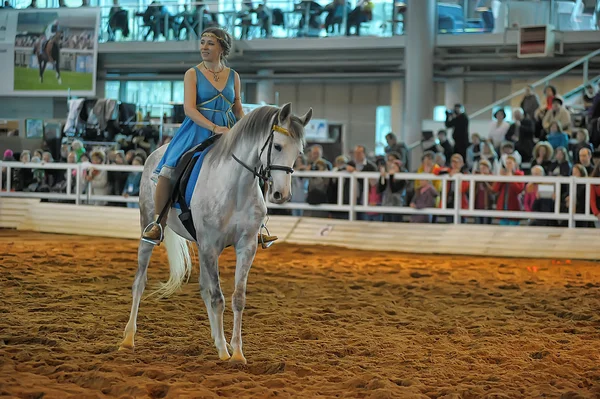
[198,247,229,360]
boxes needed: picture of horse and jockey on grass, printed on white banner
[13,8,99,96]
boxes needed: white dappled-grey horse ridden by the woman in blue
[120,103,312,364]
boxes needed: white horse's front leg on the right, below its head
[230,235,258,364]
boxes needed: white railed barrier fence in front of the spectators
[0,161,600,228]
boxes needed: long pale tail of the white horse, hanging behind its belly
[150,226,192,298]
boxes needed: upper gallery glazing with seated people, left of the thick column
[100,0,402,42]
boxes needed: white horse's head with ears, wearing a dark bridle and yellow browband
[260,103,312,204]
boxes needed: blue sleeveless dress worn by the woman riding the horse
[154,67,237,179]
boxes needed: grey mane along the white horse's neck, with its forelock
[211,105,304,160]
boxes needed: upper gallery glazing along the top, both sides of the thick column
[1,0,600,42]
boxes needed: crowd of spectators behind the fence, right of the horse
[284,85,600,227]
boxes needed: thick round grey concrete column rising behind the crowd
[402,0,437,152]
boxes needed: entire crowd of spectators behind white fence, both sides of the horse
[2,82,600,227]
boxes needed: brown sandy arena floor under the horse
[0,230,600,399]
